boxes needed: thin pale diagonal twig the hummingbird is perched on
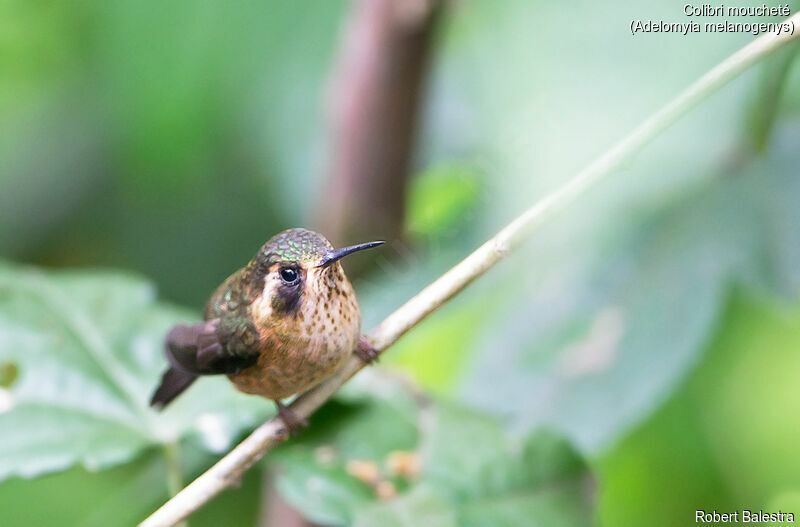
[140,12,800,527]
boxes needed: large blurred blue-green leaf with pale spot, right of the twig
[462,127,800,452]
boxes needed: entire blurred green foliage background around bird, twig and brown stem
[0,0,800,526]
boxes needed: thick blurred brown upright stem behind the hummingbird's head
[317,0,442,249]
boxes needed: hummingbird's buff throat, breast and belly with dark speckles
[229,263,361,399]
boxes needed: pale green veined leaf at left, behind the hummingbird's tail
[0,265,268,479]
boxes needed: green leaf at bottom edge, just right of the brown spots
[355,403,591,527]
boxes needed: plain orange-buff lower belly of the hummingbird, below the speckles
[228,342,355,399]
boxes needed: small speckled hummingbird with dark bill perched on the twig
[150,229,384,433]
